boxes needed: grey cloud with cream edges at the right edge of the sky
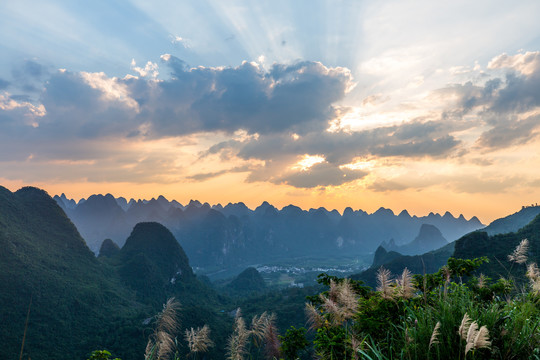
[435,53,540,150]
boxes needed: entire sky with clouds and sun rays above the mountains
[0,0,540,224]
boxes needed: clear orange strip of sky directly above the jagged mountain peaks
[0,174,540,225]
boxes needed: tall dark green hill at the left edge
[0,187,140,359]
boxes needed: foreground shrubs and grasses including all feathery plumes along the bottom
[95,240,540,360]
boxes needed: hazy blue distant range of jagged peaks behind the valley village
[56,194,483,267]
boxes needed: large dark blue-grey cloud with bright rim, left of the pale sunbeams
[150,56,352,135]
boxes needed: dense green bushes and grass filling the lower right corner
[302,257,540,360]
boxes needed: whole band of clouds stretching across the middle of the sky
[0,53,540,191]
